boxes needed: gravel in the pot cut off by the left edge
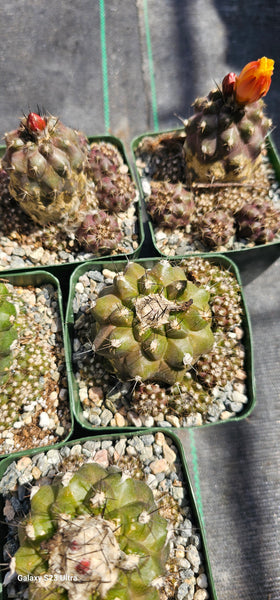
[0,280,71,454]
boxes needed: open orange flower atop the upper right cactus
[235,56,274,104]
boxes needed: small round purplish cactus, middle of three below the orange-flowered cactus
[196,210,235,248]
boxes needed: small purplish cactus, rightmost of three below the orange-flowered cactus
[235,201,280,244]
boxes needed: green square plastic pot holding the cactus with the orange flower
[131,128,280,285]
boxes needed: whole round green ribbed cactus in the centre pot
[92,261,213,384]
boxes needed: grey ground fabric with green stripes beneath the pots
[0,0,280,600]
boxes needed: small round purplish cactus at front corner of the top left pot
[76,211,123,254]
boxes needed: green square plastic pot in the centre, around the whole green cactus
[65,254,255,432]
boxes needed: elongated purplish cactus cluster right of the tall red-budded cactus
[87,142,136,213]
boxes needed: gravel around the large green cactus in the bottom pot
[0,431,212,600]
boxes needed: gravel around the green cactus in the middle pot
[69,258,248,428]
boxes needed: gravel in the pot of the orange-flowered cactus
[135,131,280,257]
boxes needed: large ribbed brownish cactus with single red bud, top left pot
[3,113,87,225]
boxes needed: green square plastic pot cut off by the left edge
[0,270,74,459]
